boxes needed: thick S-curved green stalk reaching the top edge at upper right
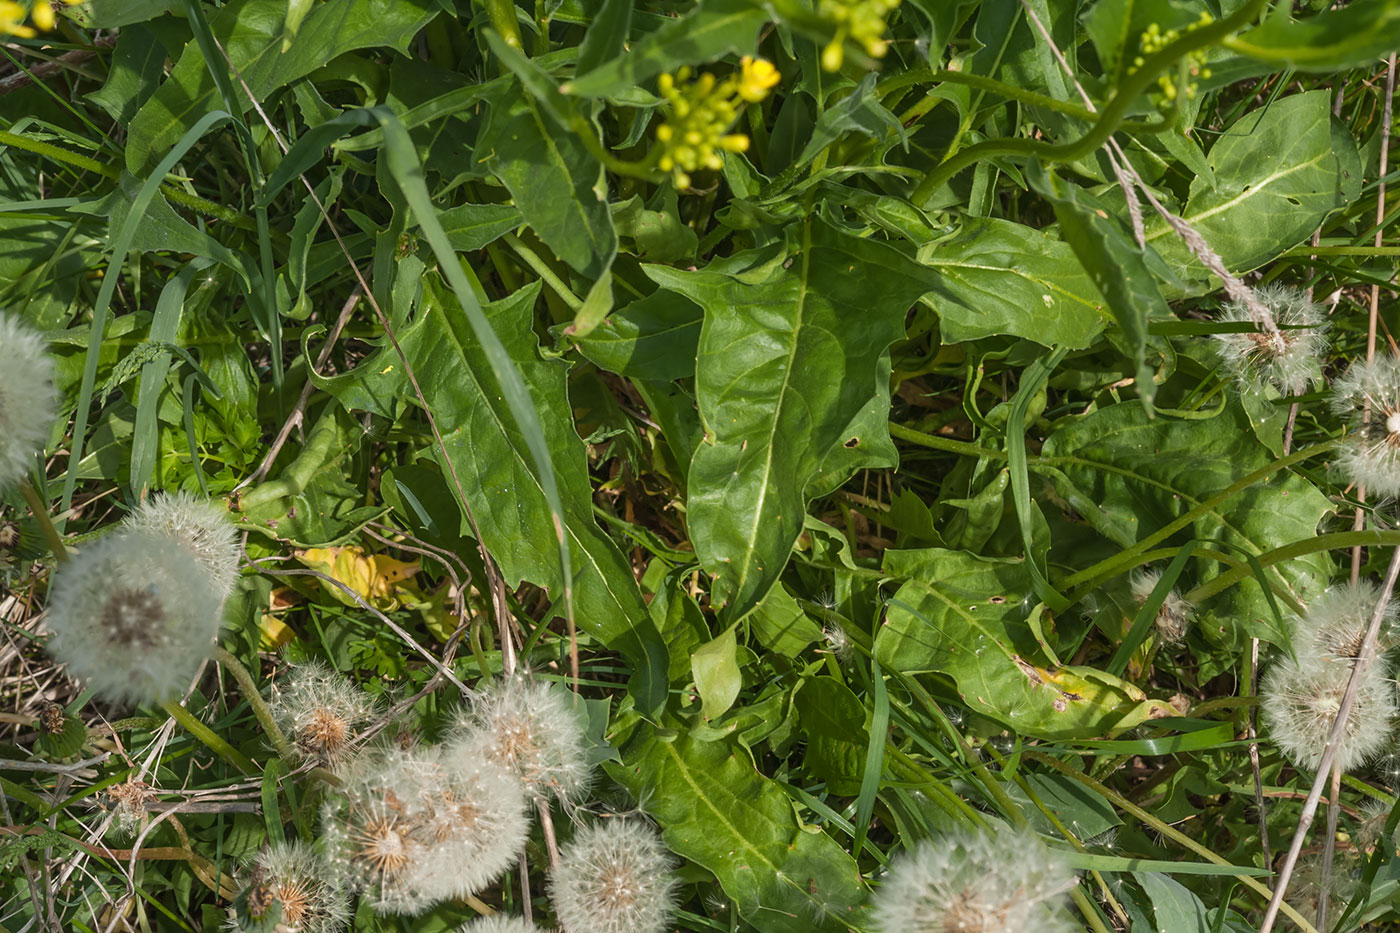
[909,0,1268,206]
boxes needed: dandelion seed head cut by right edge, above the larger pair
[1331,356,1400,497]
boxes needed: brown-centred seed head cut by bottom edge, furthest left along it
[225,841,350,933]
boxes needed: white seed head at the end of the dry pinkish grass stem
[1212,284,1327,395]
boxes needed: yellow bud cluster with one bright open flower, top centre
[657,56,780,189]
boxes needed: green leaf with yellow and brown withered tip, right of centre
[875,546,1176,738]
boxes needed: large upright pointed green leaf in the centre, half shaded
[645,220,930,619]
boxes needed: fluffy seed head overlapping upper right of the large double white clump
[447,677,592,804]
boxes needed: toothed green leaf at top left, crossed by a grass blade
[126,0,438,175]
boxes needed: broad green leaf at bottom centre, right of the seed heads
[608,726,865,933]
